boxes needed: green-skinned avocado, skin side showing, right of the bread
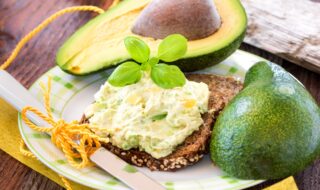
[210,62,320,179]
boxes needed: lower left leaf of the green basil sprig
[108,61,141,87]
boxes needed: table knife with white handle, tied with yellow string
[0,70,165,190]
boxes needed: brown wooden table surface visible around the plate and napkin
[0,0,320,190]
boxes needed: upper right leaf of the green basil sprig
[158,34,188,62]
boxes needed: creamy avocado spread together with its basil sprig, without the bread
[85,34,209,159]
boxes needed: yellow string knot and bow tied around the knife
[21,78,109,169]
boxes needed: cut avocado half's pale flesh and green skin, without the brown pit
[56,0,247,75]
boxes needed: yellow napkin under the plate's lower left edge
[0,98,90,190]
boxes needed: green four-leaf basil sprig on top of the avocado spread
[108,34,187,89]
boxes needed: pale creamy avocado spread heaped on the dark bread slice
[85,73,209,158]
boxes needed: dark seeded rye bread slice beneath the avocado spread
[81,74,242,171]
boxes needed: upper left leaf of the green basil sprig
[124,36,150,63]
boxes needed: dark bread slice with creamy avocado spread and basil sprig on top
[83,34,242,171]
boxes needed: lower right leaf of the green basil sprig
[151,64,186,89]
